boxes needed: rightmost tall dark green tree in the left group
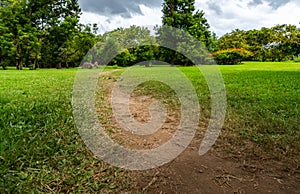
[28,0,81,68]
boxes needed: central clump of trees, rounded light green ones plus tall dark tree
[83,0,217,68]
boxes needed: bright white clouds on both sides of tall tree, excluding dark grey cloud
[81,0,300,36]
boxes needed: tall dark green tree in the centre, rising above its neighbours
[158,0,214,65]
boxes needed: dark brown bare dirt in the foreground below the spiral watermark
[132,140,300,194]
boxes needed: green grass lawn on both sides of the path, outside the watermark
[0,62,300,193]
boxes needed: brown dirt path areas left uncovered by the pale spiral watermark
[99,69,300,194]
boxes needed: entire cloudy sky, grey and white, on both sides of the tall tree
[79,0,300,36]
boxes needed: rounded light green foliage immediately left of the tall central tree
[85,26,157,67]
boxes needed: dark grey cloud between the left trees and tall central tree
[79,0,162,18]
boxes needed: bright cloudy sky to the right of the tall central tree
[196,0,300,36]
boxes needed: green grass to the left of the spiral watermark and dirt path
[0,70,127,193]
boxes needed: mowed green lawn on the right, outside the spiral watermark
[182,62,300,164]
